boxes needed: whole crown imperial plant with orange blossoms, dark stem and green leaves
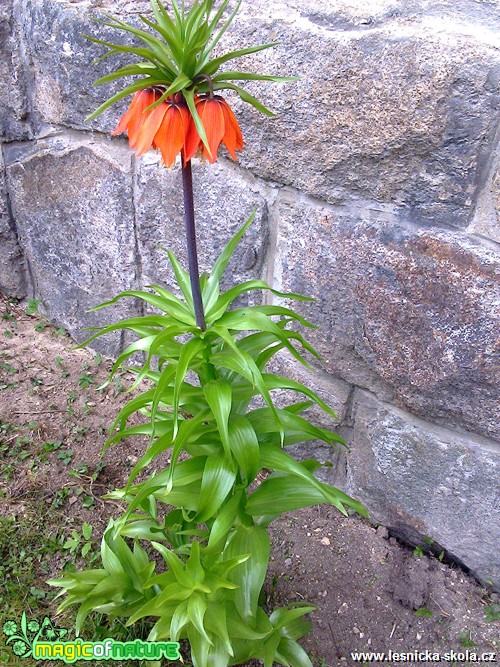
[49,0,366,667]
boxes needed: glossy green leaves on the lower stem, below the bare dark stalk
[50,216,366,667]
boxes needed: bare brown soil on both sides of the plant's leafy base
[0,295,500,667]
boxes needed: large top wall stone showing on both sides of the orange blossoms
[20,0,498,235]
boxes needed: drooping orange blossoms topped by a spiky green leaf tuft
[87,0,297,167]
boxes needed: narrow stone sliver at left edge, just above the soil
[0,150,26,298]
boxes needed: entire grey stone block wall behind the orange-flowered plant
[0,0,500,585]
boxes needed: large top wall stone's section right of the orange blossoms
[226,3,499,227]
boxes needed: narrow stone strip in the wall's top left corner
[0,0,29,141]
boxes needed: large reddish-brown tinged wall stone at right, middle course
[276,197,500,436]
